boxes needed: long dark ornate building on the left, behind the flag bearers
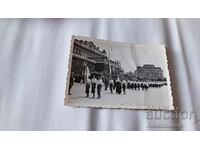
[71,39,123,82]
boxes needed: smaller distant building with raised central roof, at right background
[134,64,166,81]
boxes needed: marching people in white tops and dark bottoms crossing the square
[69,75,167,99]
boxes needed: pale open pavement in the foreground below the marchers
[68,83,170,109]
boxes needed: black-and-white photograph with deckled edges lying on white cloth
[65,36,174,110]
